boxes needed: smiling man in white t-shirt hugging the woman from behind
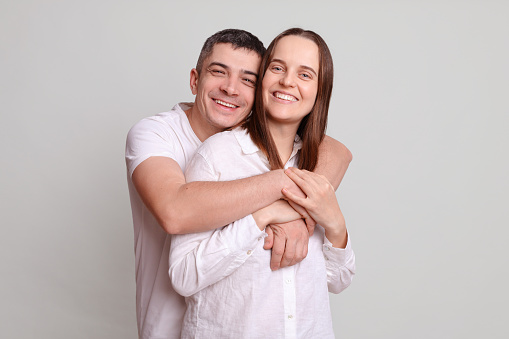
[126,30,351,339]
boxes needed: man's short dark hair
[196,28,265,74]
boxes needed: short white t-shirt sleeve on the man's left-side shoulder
[125,118,178,177]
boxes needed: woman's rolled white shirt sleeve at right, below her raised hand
[323,235,355,293]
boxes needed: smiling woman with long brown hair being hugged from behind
[170,28,355,338]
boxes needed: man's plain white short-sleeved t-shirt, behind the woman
[125,103,201,339]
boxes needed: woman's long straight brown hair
[244,28,334,171]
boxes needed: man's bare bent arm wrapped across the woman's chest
[132,157,298,234]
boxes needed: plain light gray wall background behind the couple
[0,0,509,339]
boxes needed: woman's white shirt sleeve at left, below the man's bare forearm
[169,215,266,297]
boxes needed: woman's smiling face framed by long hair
[262,35,320,125]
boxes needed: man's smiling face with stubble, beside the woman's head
[191,43,261,137]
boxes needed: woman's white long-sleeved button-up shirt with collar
[169,128,355,338]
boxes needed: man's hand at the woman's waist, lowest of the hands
[263,219,309,271]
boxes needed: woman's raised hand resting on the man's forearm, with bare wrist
[282,168,347,248]
